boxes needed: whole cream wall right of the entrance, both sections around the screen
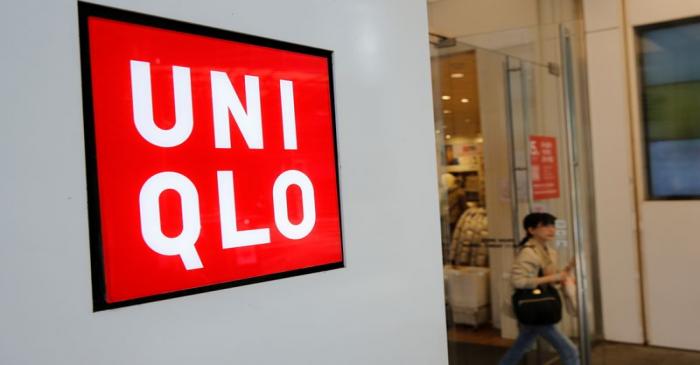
[584,0,700,350]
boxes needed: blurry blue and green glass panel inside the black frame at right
[638,20,700,199]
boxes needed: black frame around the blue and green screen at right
[634,17,700,201]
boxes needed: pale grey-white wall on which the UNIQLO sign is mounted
[0,0,447,364]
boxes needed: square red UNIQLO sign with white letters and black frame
[79,3,343,310]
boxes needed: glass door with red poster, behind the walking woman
[504,57,587,363]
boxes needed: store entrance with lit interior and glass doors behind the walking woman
[431,26,595,364]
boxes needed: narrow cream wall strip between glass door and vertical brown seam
[584,0,644,343]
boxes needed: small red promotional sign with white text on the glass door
[530,136,559,200]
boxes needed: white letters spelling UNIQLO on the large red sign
[130,60,316,270]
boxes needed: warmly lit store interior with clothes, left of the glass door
[433,45,510,346]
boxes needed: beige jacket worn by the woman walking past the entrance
[510,240,559,289]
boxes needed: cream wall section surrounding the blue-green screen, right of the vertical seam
[625,0,700,351]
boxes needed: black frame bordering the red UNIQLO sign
[78,1,345,312]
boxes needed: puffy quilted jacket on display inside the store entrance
[448,203,488,267]
